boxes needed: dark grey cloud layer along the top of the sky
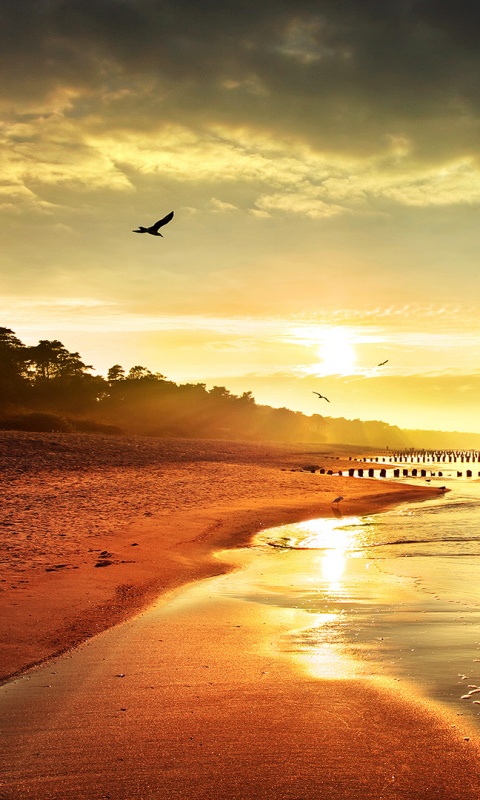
[0,0,480,157]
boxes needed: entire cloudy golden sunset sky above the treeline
[0,0,480,433]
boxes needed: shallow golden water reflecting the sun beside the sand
[218,466,480,728]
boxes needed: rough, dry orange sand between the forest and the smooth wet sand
[0,432,437,679]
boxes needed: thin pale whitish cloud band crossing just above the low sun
[4,292,480,338]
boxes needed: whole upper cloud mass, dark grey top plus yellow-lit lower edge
[0,0,480,220]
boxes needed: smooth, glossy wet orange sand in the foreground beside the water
[0,536,480,800]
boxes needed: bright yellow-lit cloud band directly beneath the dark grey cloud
[0,108,480,219]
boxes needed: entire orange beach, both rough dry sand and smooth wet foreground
[0,433,480,800]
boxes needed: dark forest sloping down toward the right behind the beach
[0,328,480,449]
